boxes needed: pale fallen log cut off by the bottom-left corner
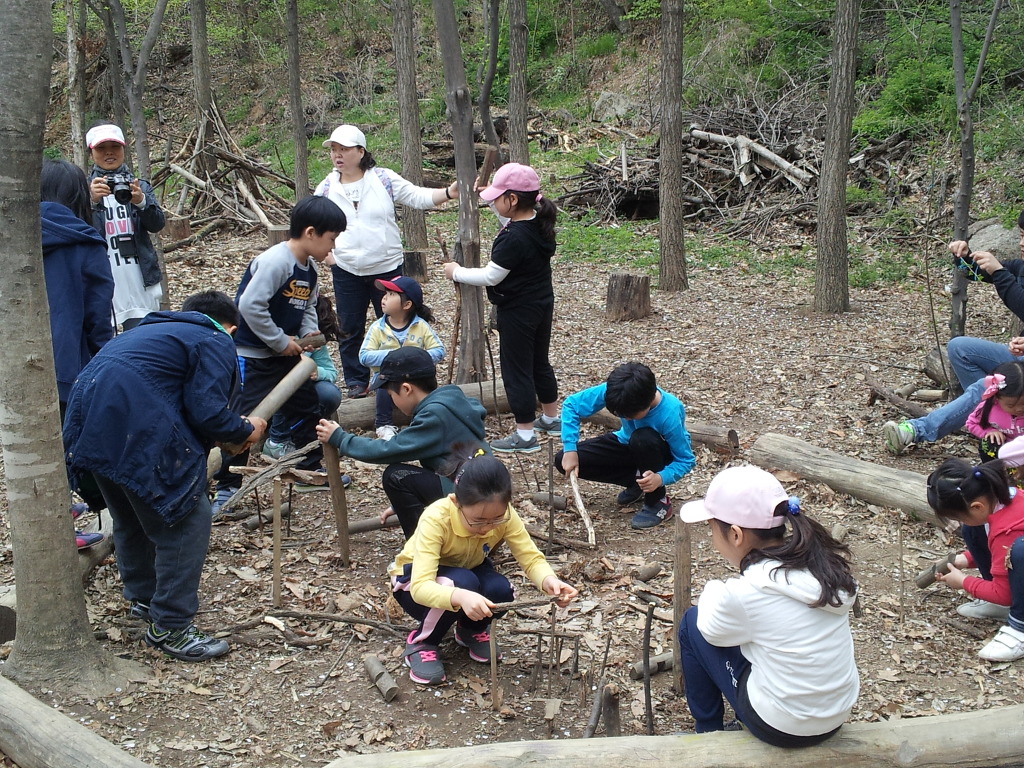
[0,677,150,768]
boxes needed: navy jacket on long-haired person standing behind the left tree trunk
[39,203,114,402]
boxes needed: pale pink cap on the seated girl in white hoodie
[679,466,790,530]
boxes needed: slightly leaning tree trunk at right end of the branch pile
[814,0,860,313]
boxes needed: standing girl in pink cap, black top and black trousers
[444,163,562,454]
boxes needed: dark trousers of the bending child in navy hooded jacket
[94,475,211,630]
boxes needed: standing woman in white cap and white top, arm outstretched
[314,125,459,397]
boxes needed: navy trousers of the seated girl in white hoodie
[679,605,839,746]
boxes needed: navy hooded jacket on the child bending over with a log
[63,312,252,525]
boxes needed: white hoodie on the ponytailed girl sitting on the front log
[697,560,860,736]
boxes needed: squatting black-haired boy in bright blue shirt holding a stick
[555,362,695,528]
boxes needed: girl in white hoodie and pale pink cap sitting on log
[679,466,860,748]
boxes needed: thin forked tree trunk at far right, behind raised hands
[949,0,1002,338]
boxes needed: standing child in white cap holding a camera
[85,123,164,331]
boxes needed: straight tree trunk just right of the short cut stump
[657,0,689,291]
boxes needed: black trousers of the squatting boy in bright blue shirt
[555,427,672,504]
